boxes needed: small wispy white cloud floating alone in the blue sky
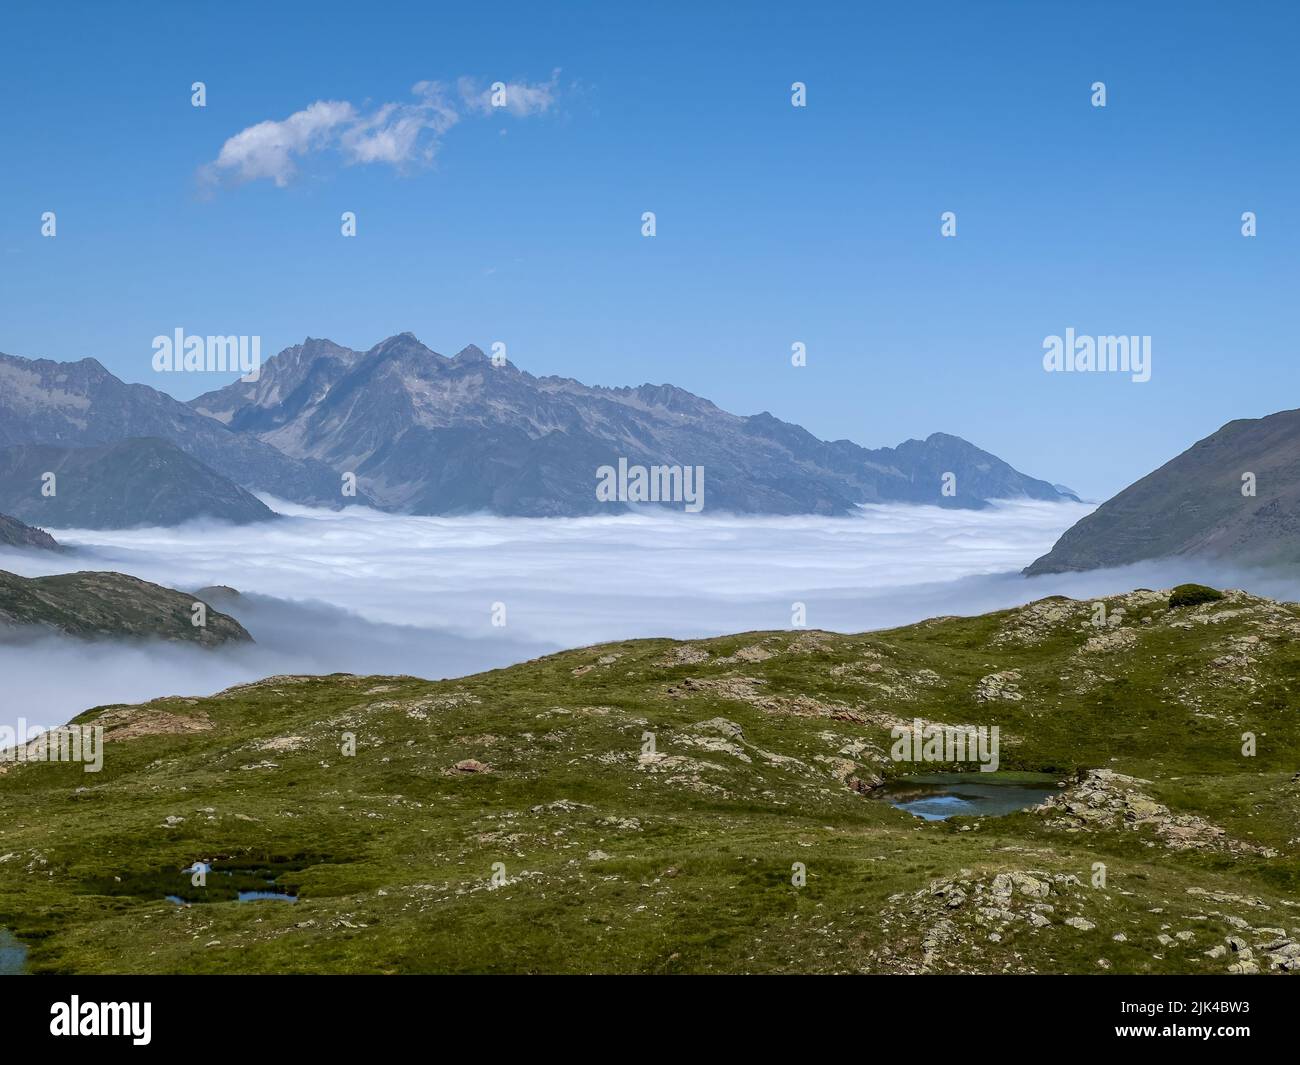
[199,72,559,189]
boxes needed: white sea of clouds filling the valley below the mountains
[0,499,1300,726]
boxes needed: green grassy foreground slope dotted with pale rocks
[0,593,1300,973]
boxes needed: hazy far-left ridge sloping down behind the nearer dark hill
[0,354,351,506]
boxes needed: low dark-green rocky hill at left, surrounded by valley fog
[0,570,252,648]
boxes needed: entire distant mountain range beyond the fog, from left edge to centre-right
[0,333,1075,527]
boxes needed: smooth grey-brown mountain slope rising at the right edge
[1024,411,1300,575]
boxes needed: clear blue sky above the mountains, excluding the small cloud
[0,3,1300,498]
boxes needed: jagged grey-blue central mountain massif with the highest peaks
[191,333,1073,516]
